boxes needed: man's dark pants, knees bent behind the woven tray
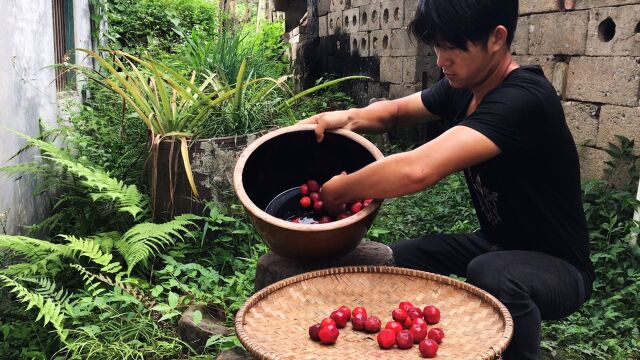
[391,233,587,360]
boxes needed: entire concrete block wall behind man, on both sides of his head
[297,0,640,178]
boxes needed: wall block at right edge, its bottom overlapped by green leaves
[596,105,640,155]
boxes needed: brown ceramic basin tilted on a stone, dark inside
[233,125,383,260]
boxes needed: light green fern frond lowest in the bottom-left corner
[0,275,68,343]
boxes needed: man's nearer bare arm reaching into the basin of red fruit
[322,126,500,210]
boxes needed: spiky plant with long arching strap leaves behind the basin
[65,49,366,215]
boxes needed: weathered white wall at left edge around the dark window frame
[0,0,91,234]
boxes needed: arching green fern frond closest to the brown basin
[115,214,200,274]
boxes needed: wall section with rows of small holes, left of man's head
[317,0,440,104]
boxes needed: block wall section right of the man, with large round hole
[512,0,640,178]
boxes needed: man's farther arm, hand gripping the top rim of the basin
[299,92,438,141]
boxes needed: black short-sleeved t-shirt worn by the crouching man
[422,66,594,288]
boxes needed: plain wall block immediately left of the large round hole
[529,11,589,55]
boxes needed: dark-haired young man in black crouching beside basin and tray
[300,0,594,360]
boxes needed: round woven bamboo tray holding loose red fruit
[235,266,513,360]
